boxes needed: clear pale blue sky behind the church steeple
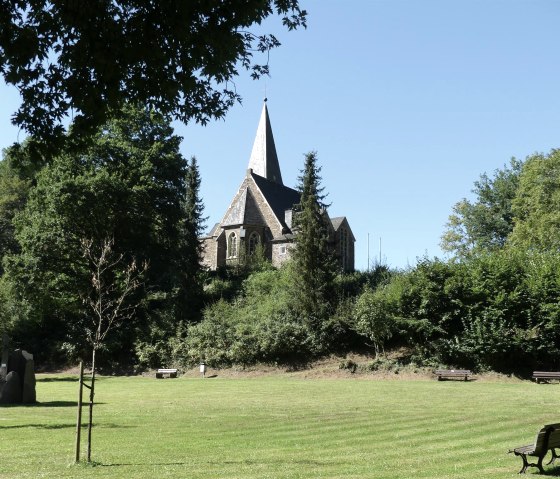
[0,0,560,269]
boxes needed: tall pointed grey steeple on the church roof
[249,98,283,185]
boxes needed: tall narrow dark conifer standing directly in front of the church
[293,152,336,330]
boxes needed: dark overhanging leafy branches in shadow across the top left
[0,0,306,147]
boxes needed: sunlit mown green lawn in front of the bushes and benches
[0,375,560,479]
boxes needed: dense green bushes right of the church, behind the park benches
[350,253,560,372]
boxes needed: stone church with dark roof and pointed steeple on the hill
[201,99,355,272]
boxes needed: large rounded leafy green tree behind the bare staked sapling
[3,107,186,366]
